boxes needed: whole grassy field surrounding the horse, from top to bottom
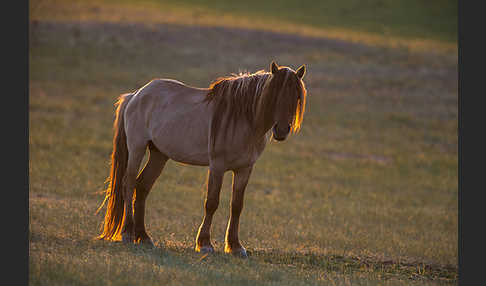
[29,0,458,285]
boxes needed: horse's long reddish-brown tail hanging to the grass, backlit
[96,94,133,240]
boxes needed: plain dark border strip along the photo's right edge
[458,0,486,285]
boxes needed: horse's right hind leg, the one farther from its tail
[133,143,168,246]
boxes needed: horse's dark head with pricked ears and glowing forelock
[270,62,306,141]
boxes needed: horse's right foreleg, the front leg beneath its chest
[224,166,253,257]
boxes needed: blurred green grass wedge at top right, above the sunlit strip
[142,0,458,42]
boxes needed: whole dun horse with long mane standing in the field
[97,61,307,257]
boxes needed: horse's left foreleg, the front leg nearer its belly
[195,169,224,253]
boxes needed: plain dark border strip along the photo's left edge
[6,1,29,285]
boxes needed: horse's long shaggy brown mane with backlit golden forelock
[205,70,306,150]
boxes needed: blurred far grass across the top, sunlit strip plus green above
[30,0,457,54]
